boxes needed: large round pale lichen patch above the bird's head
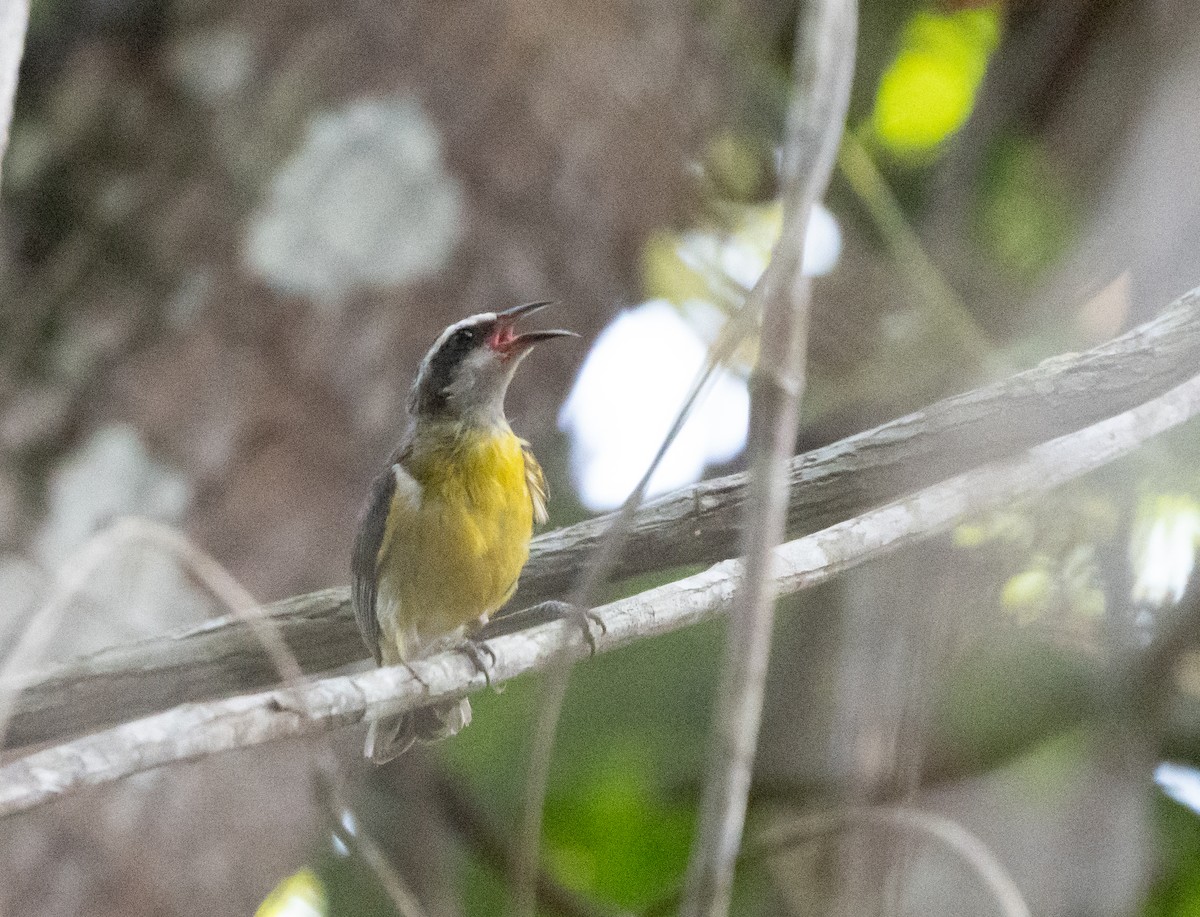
[244,98,463,306]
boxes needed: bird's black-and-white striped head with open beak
[408,302,577,422]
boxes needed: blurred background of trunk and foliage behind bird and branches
[7,0,1200,917]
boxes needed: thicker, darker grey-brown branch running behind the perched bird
[7,289,1200,747]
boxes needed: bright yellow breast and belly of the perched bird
[377,430,533,659]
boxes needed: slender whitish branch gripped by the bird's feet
[0,364,1200,816]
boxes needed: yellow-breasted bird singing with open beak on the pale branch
[350,301,577,763]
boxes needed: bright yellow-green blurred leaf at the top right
[870,5,1002,162]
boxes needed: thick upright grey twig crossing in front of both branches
[680,0,858,917]
